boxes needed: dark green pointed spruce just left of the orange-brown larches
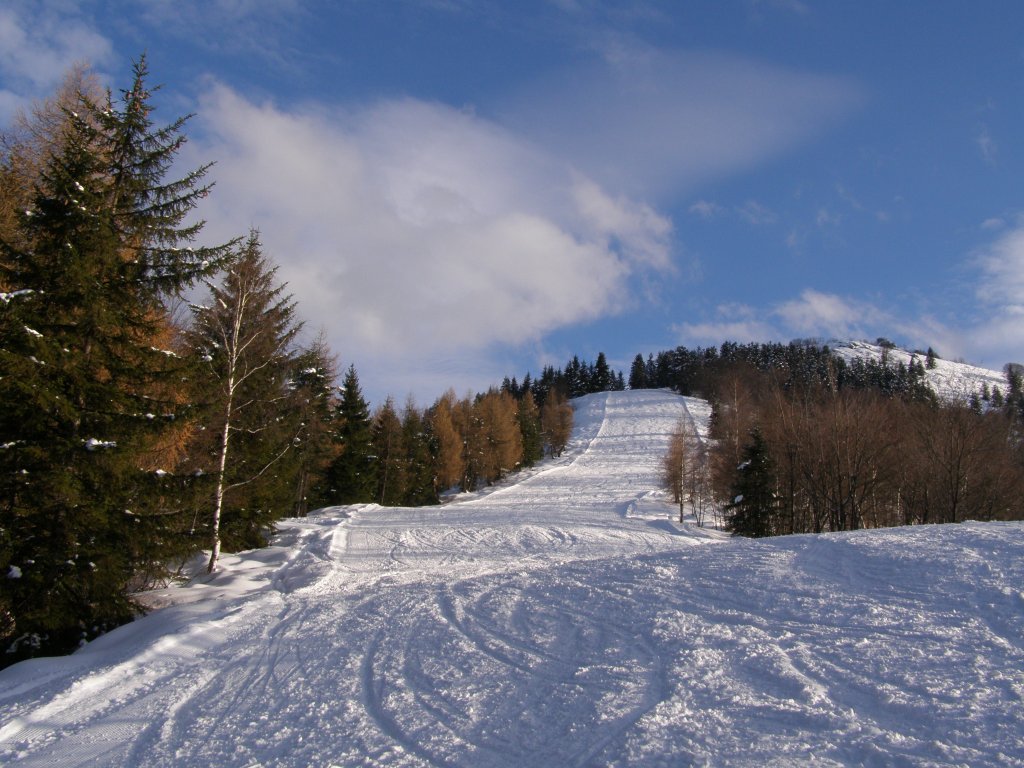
[328,366,377,504]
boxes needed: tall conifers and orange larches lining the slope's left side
[0,63,606,666]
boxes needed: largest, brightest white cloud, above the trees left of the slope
[187,84,672,403]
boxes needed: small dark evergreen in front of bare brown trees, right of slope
[726,427,778,537]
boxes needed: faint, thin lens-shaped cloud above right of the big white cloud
[495,46,862,197]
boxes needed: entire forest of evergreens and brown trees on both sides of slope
[0,58,1024,666]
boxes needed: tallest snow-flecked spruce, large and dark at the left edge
[0,61,224,660]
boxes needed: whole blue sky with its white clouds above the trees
[0,0,1024,403]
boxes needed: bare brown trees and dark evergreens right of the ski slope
[666,342,1024,537]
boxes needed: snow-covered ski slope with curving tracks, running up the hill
[0,391,1024,768]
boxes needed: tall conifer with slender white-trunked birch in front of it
[191,231,303,571]
